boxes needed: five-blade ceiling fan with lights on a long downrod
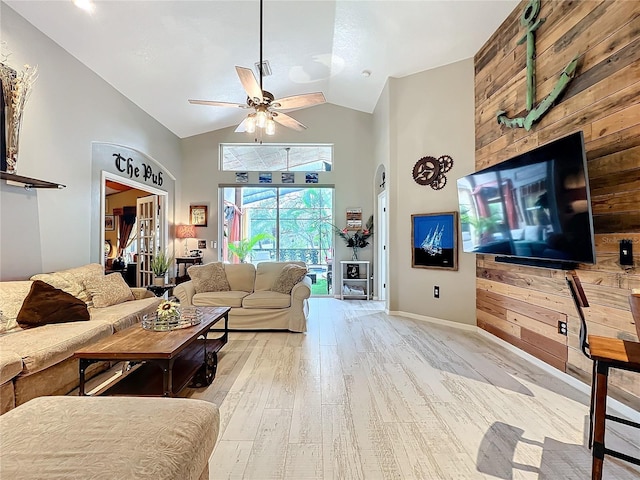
[189,0,325,135]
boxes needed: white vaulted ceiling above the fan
[3,0,519,138]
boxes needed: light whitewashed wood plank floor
[185,298,640,480]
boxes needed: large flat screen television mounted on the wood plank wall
[458,132,596,268]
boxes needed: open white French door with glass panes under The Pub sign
[136,195,167,287]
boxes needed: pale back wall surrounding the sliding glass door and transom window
[176,104,375,288]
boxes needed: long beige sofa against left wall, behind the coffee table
[0,264,161,413]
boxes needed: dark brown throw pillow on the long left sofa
[16,280,89,328]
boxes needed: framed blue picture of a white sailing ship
[411,212,458,271]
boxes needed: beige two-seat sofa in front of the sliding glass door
[173,262,311,332]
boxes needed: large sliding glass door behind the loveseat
[222,186,333,295]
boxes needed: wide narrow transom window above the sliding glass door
[220,143,333,172]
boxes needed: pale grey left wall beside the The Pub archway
[0,3,181,280]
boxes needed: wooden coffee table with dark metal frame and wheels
[73,307,230,397]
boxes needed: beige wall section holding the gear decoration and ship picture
[387,59,476,324]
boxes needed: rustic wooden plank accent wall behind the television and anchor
[475,0,640,408]
